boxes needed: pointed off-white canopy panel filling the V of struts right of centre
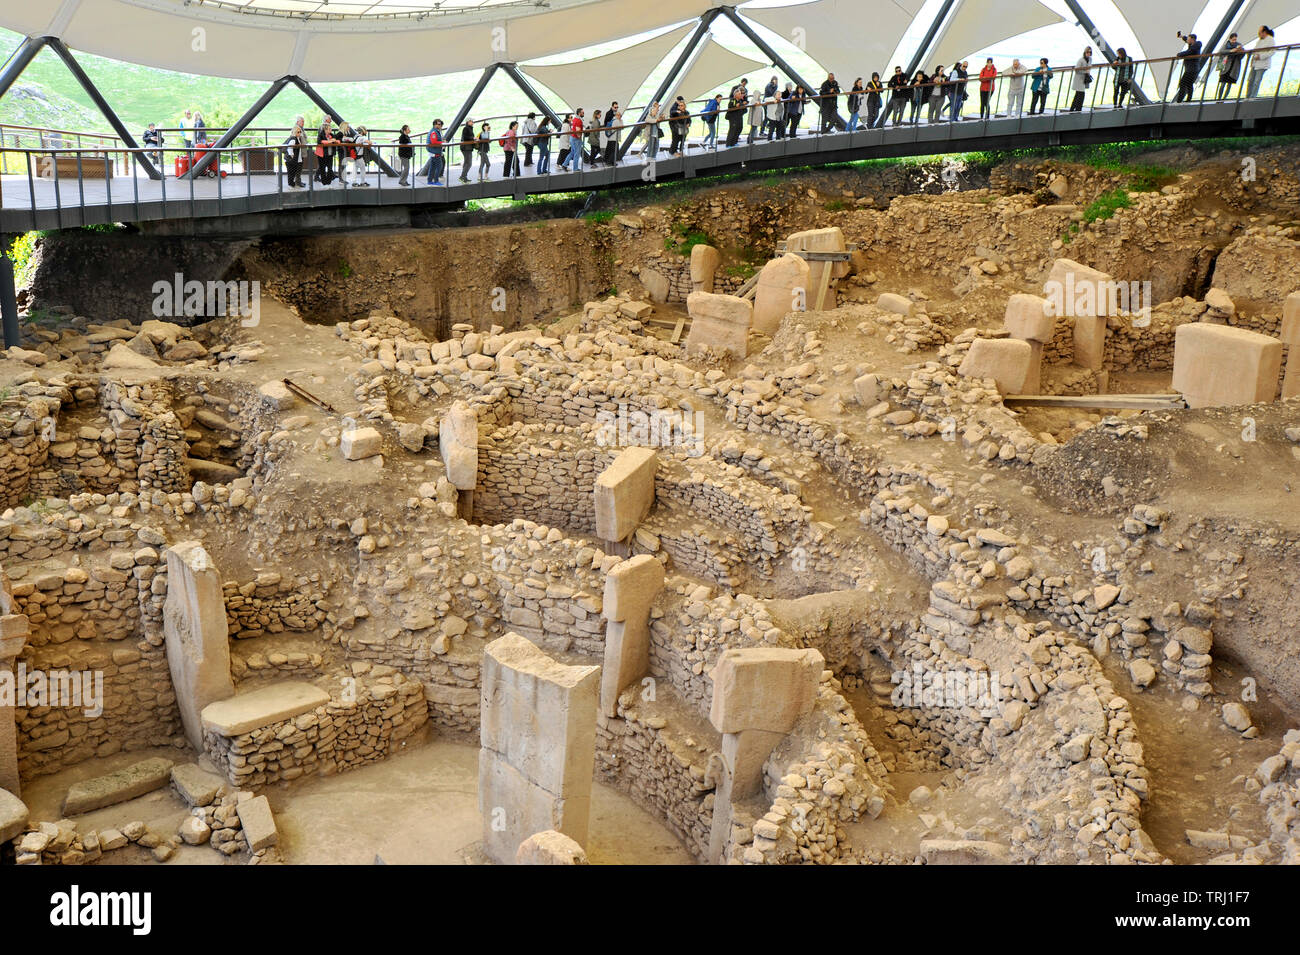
[741,0,926,82]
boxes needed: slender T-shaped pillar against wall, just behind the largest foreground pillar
[601,554,663,717]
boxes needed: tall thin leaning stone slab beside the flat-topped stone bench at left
[163,541,235,751]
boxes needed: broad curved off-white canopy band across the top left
[0,0,715,83]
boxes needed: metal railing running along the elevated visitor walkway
[0,44,1300,231]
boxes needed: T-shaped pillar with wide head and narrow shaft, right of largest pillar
[709,647,826,863]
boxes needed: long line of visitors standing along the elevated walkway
[239,26,1274,188]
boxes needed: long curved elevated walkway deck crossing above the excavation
[0,95,1300,233]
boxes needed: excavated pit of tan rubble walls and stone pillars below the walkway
[0,138,1300,882]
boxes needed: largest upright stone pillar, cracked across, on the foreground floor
[478,633,601,864]
